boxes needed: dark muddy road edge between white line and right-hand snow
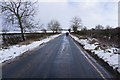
[70,36,120,80]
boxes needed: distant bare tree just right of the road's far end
[71,17,82,32]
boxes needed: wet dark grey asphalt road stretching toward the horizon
[2,34,114,78]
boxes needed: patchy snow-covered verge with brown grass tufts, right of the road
[70,35,120,73]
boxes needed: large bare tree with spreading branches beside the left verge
[0,0,36,41]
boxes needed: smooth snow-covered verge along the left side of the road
[0,34,61,63]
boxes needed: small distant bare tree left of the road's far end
[48,20,60,33]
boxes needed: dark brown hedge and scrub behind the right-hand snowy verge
[76,28,120,47]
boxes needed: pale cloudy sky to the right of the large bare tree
[34,0,118,28]
